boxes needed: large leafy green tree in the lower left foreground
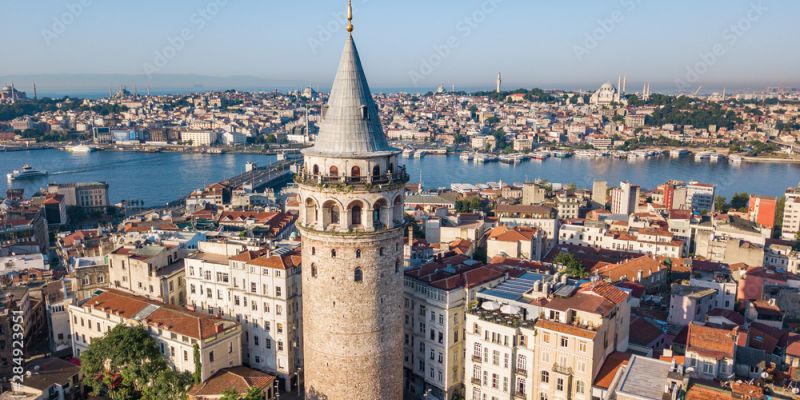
[81,325,191,400]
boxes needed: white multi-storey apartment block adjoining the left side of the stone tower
[186,242,303,390]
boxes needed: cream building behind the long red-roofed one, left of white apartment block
[108,244,186,305]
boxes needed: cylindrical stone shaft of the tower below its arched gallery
[300,223,403,400]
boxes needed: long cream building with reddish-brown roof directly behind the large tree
[69,289,242,380]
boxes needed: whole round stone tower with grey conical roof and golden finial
[295,4,408,400]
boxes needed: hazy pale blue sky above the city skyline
[0,0,800,90]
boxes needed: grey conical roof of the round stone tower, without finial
[306,36,397,157]
